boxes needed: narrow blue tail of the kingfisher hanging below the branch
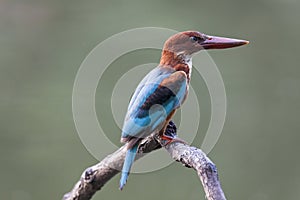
[120,144,138,190]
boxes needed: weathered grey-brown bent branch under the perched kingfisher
[63,122,226,200]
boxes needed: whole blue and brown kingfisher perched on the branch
[119,31,249,190]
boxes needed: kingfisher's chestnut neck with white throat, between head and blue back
[160,50,192,80]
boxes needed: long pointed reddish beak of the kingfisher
[200,35,249,49]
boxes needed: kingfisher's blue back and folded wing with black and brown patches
[122,67,187,139]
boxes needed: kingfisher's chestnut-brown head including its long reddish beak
[163,31,249,56]
